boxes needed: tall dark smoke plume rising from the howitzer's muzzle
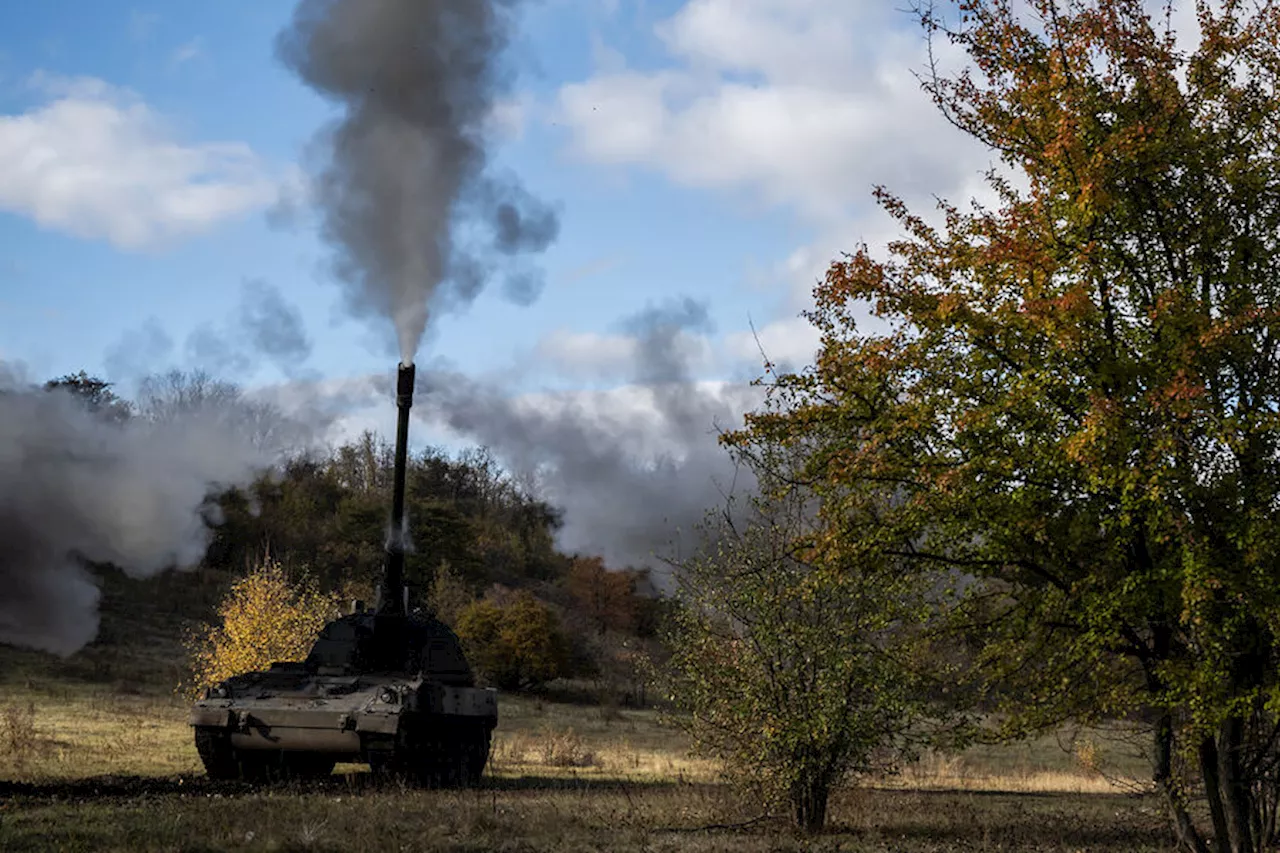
[276,0,559,364]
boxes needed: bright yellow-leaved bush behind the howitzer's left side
[186,560,340,695]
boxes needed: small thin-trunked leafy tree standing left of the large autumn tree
[666,448,925,831]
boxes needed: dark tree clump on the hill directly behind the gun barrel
[206,434,567,594]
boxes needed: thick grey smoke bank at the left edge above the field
[0,362,297,654]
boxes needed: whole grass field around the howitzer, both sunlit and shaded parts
[0,568,1171,853]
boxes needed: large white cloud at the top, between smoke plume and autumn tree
[558,0,991,225]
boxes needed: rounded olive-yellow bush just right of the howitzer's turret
[454,592,572,690]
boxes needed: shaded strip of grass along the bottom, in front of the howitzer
[0,776,1169,853]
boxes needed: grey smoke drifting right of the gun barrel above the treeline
[404,300,762,576]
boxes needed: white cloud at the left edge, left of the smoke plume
[0,74,278,250]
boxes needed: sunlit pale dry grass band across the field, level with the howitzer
[0,686,1143,794]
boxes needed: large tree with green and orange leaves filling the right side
[750,0,1280,853]
